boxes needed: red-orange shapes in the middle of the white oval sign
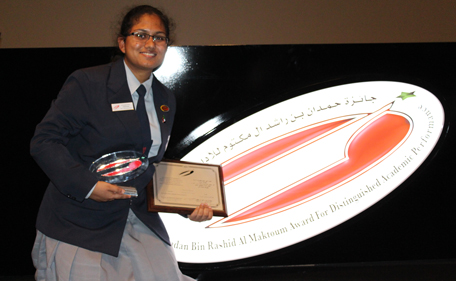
[209,103,412,227]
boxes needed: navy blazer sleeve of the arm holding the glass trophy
[30,70,97,202]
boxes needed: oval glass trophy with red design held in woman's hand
[89,150,149,196]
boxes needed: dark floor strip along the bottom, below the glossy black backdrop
[0,260,456,281]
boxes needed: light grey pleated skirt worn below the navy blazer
[32,210,194,281]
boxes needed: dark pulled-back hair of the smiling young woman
[118,5,174,45]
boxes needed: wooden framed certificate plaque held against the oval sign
[147,160,228,217]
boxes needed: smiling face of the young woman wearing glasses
[117,14,168,83]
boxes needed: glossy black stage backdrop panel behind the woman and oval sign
[0,43,456,275]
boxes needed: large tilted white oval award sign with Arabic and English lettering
[162,81,444,263]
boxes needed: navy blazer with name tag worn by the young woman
[31,60,176,256]
